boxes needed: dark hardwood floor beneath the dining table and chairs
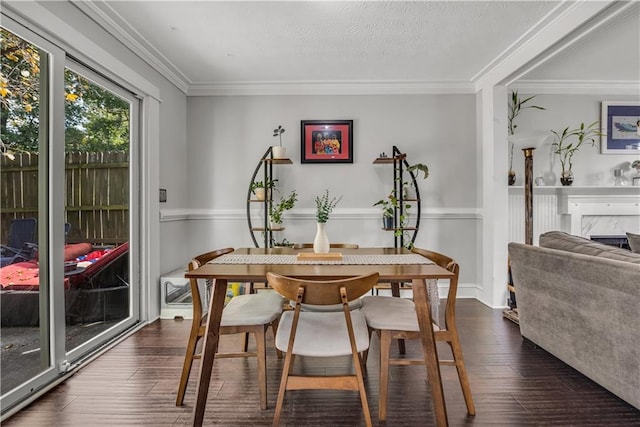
[3,300,640,427]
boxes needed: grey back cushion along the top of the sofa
[540,231,640,264]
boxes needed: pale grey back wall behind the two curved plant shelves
[187,95,480,296]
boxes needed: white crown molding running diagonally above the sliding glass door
[73,0,189,94]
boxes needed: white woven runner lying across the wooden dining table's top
[210,253,433,265]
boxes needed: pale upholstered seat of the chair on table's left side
[220,292,283,326]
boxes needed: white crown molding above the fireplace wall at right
[510,80,640,96]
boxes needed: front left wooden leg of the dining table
[193,279,227,427]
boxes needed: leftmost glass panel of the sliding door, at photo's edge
[0,28,51,396]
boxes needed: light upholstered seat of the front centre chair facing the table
[276,311,369,357]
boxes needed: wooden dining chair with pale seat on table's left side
[176,248,284,409]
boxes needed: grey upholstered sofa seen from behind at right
[509,231,640,409]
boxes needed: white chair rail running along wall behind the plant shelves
[160,208,482,222]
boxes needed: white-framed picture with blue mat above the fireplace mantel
[600,101,640,154]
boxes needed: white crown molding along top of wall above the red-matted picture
[187,80,476,96]
